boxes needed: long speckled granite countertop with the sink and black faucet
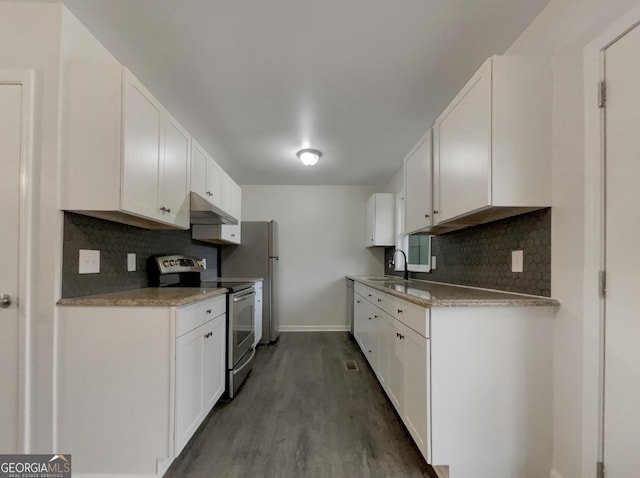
[347,276,560,307]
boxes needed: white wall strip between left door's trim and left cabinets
[0,3,62,453]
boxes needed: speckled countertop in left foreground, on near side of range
[58,287,227,307]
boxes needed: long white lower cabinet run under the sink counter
[354,282,554,478]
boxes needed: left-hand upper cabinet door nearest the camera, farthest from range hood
[121,72,162,219]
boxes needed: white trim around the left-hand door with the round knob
[0,69,35,453]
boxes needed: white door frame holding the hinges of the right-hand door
[582,7,640,478]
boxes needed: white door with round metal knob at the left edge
[0,78,23,453]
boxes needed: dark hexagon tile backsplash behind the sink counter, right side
[385,208,551,297]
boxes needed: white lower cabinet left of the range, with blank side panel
[54,295,226,477]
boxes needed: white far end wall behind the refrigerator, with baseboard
[242,186,383,330]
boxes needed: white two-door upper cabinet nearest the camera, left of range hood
[60,64,191,229]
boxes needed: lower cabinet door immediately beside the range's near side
[203,314,226,412]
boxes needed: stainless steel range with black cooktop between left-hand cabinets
[151,255,256,398]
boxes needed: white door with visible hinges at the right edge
[604,20,640,477]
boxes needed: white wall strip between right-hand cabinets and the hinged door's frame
[506,0,640,478]
